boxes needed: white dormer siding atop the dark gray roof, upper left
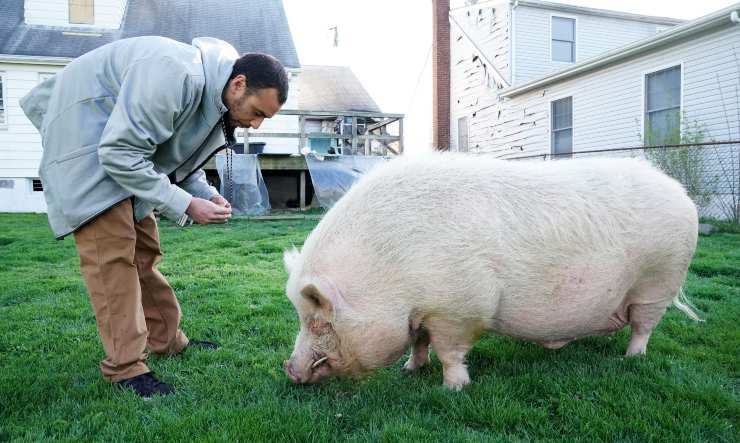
[25,0,126,29]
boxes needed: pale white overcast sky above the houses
[283,0,737,154]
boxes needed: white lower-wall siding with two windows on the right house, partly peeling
[470,25,740,160]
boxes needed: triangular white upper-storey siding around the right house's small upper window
[513,6,666,84]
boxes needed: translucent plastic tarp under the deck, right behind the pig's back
[306,154,390,209]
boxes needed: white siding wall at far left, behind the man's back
[0,63,61,212]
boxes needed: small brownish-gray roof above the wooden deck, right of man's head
[298,65,381,112]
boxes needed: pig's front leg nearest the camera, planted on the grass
[429,321,474,391]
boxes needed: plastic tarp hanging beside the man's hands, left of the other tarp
[216,154,270,215]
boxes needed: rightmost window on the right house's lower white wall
[645,66,681,145]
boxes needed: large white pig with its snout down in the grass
[284,154,697,389]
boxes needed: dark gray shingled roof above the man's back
[0,0,300,68]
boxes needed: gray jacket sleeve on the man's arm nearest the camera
[98,57,197,220]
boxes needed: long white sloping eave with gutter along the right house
[500,3,740,97]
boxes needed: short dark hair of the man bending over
[229,52,288,105]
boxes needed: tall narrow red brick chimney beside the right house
[432,0,450,151]
